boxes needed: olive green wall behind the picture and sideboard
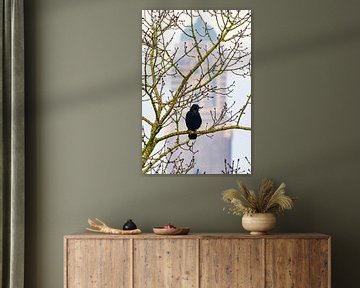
[25,0,360,288]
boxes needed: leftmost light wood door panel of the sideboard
[65,239,132,288]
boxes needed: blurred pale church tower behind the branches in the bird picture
[169,17,232,174]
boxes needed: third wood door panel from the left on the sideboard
[200,239,264,288]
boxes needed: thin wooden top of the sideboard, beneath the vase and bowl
[64,232,330,239]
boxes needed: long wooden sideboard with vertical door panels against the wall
[64,233,331,288]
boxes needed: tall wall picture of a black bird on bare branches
[141,10,252,174]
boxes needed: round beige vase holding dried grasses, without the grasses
[242,213,276,235]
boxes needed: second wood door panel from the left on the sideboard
[134,238,198,288]
